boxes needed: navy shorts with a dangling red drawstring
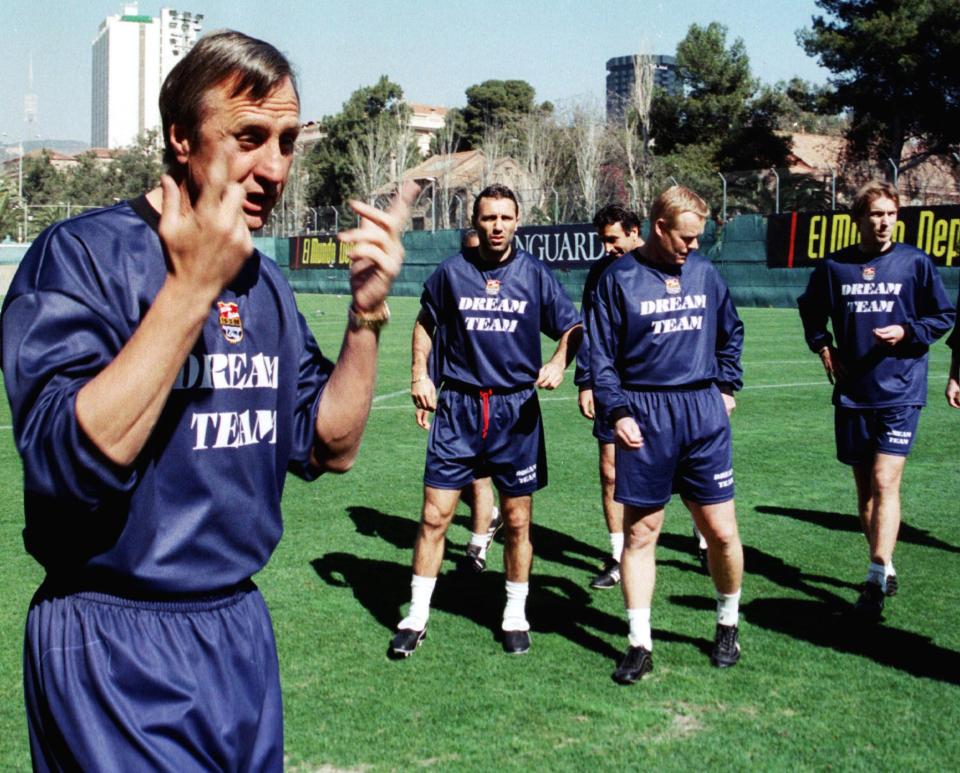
[423,386,547,496]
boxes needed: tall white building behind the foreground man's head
[90,3,203,148]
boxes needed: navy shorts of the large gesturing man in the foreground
[23,583,283,773]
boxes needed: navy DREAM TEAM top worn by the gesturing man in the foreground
[2,197,333,595]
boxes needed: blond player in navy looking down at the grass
[587,186,743,684]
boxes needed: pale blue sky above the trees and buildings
[0,0,829,144]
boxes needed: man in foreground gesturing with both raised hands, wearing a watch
[2,31,415,771]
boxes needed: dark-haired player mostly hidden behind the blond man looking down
[574,204,707,590]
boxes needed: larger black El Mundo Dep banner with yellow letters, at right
[767,206,960,268]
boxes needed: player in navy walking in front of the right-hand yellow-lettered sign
[797,182,954,621]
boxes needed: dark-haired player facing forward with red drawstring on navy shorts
[388,185,582,658]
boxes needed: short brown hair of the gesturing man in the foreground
[160,30,300,169]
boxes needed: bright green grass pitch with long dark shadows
[0,295,960,771]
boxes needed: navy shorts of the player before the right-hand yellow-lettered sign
[834,405,920,465]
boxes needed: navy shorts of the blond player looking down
[614,386,734,508]
